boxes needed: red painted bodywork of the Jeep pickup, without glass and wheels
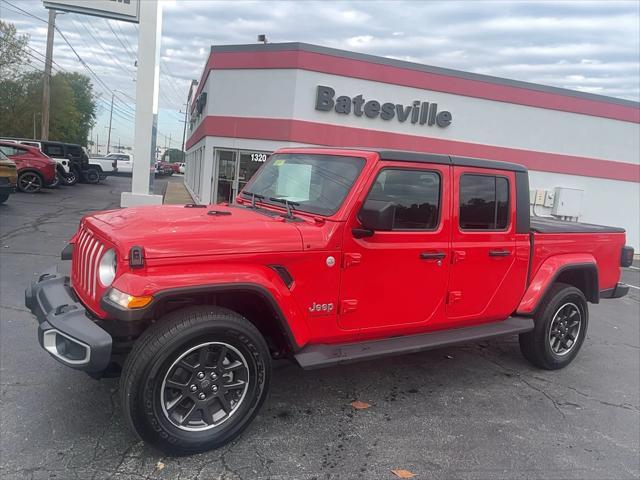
[67,148,625,347]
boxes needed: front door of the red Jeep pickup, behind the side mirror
[339,162,451,336]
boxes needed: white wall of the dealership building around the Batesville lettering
[187,69,640,251]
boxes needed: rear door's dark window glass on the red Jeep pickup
[460,174,509,230]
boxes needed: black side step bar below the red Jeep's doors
[294,317,533,370]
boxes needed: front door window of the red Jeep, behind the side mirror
[367,169,440,230]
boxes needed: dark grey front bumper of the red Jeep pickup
[25,267,112,373]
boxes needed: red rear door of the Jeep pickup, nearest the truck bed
[447,166,522,326]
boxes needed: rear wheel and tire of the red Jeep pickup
[519,283,589,370]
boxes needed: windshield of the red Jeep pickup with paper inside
[242,153,365,215]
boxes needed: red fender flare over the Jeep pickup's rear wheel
[516,254,600,315]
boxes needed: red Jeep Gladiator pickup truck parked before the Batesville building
[25,148,633,455]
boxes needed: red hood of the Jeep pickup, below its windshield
[85,205,302,259]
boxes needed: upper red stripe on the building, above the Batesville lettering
[190,50,640,123]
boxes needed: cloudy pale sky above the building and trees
[0,0,640,148]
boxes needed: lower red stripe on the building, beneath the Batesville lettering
[187,116,640,182]
